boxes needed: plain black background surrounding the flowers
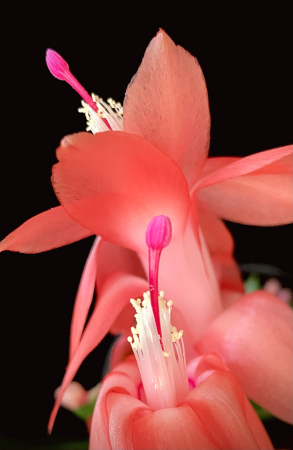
[0,2,293,446]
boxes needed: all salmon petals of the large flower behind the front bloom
[0,31,292,427]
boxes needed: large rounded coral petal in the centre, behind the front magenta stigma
[52,131,190,250]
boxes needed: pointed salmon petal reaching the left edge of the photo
[0,206,93,253]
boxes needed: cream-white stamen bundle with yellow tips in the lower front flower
[128,291,188,410]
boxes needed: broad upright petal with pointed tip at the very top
[123,31,210,183]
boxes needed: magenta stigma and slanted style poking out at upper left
[46,48,111,130]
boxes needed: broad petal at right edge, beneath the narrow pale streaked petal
[198,173,293,226]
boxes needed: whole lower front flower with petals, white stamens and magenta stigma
[90,216,273,450]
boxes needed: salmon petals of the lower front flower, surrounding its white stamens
[89,354,273,450]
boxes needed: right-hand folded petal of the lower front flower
[184,355,273,449]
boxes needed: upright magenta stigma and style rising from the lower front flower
[146,215,172,343]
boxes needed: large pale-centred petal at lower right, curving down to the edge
[196,291,293,422]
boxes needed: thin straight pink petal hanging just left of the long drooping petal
[69,237,101,358]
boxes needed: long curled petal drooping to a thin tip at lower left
[49,274,148,430]
